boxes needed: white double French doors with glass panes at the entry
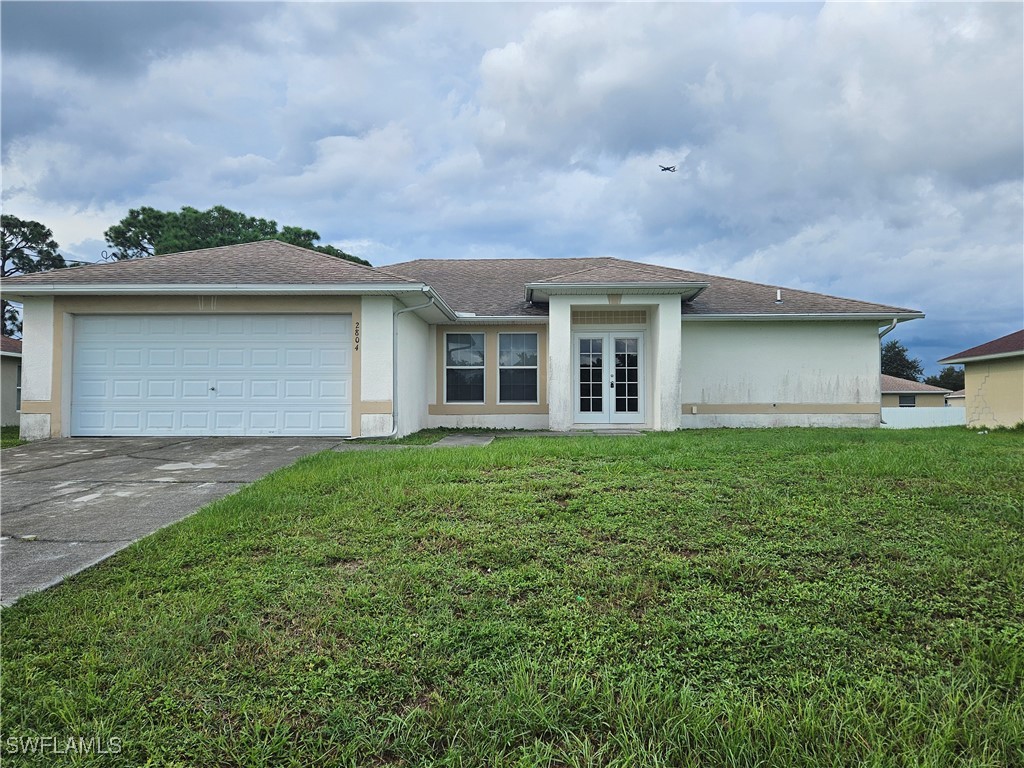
[572,331,644,424]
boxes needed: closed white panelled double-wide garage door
[71,314,352,436]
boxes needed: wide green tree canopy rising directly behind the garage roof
[103,206,370,266]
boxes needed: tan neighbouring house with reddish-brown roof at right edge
[939,330,1024,427]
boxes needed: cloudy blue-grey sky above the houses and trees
[0,0,1024,373]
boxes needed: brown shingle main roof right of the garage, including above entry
[386,257,915,316]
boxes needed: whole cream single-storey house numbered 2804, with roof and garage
[3,241,924,438]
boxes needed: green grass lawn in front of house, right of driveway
[0,428,1024,767]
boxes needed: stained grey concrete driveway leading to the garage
[0,437,340,605]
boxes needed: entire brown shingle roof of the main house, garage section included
[4,240,913,317]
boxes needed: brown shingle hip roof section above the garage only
[4,240,408,288]
